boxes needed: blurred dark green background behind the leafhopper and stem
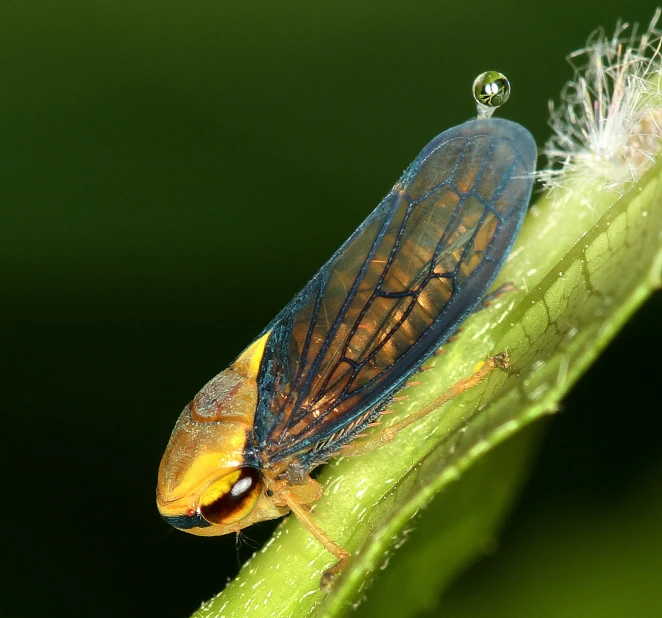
[0,0,662,618]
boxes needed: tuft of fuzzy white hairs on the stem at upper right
[538,8,662,194]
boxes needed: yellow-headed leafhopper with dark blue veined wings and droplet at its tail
[157,72,536,581]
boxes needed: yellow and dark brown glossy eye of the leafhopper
[200,468,262,524]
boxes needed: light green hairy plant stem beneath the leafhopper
[195,156,662,618]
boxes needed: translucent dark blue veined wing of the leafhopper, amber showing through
[254,119,536,466]
